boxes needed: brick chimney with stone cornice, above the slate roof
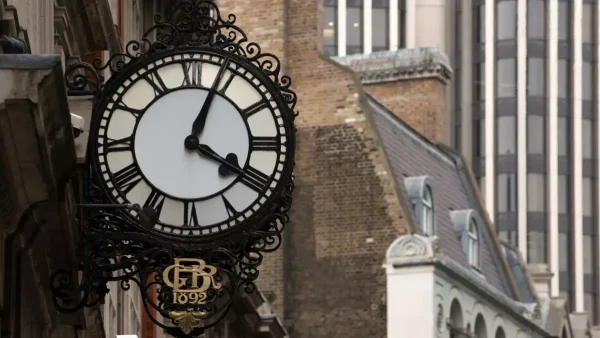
[333,47,452,144]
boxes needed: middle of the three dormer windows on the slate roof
[450,209,481,269]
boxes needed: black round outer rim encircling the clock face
[88,47,295,244]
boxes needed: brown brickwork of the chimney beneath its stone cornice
[365,77,449,144]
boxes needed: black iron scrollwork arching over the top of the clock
[63,0,297,115]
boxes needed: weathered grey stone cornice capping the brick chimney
[332,47,452,84]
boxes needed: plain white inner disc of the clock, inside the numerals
[134,88,249,200]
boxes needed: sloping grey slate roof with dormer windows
[367,97,520,299]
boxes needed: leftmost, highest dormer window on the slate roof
[404,176,435,236]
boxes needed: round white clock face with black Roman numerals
[94,52,293,236]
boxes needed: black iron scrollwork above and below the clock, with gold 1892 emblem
[50,0,297,337]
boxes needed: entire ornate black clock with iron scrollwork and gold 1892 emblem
[51,0,296,337]
